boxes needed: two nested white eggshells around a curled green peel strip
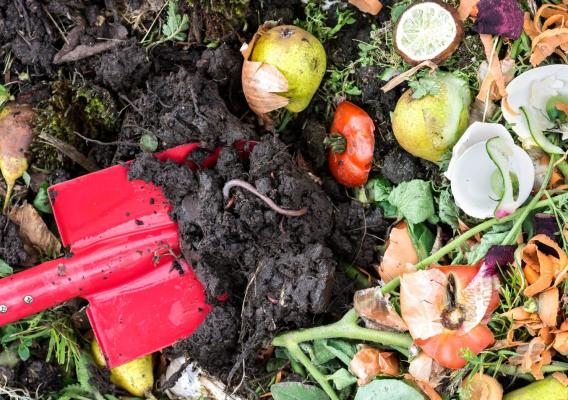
[446,122,535,219]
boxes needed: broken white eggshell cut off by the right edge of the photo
[501,64,568,145]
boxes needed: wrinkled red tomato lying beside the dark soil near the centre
[327,101,375,187]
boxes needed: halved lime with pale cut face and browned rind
[394,1,463,64]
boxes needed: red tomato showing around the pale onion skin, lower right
[415,264,499,369]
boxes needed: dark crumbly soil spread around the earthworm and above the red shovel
[0,0,431,391]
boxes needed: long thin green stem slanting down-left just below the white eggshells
[382,193,568,294]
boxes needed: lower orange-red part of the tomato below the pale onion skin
[416,324,495,369]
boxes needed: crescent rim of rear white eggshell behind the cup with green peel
[445,122,514,180]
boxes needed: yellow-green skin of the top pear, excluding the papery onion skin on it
[250,25,326,113]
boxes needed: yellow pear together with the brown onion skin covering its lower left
[241,23,326,118]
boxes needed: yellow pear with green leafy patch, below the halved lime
[391,72,471,161]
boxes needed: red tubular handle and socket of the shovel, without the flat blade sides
[0,223,179,326]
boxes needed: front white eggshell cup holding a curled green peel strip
[451,141,534,219]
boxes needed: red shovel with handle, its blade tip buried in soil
[0,144,216,368]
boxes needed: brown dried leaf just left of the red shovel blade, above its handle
[10,203,61,254]
